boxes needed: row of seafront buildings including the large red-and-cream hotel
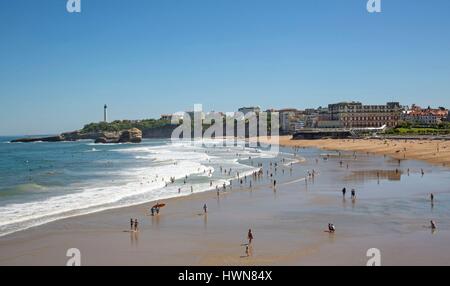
[162,101,450,133]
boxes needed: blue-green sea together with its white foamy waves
[0,137,284,236]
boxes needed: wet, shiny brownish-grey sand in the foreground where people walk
[0,149,450,265]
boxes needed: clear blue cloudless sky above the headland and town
[0,0,450,135]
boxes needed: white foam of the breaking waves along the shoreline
[0,140,278,236]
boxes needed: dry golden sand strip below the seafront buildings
[252,136,450,166]
